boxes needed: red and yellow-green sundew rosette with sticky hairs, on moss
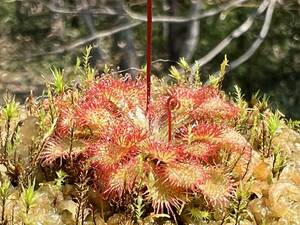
[39,53,252,211]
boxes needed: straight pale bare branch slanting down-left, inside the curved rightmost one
[194,0,269,69]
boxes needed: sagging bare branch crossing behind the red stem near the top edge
[123,0,247,23]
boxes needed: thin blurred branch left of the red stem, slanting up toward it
[29,21,142,57]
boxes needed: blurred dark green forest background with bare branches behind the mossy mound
[0,0,300,119]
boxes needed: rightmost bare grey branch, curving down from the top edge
[229,0,276,70]
